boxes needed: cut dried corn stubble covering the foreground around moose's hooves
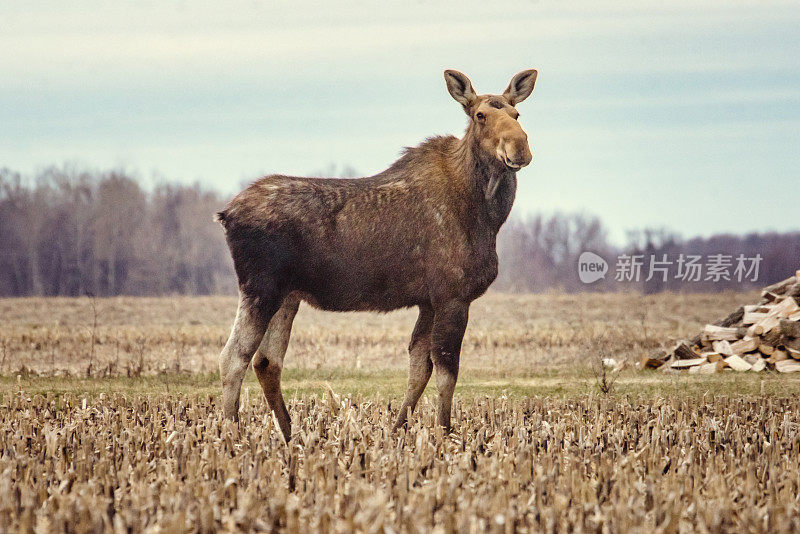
[0,393,800,532]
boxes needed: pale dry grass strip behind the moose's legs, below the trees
[0,293,753,376]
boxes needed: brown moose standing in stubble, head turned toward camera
[215,69,538,442]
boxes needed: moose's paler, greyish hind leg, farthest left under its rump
[219,294,269,421]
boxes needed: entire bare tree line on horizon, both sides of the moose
[0,167,800,296]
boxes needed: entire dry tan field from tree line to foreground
[0,293,800,532]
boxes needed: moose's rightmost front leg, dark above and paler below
[431,301,469,432]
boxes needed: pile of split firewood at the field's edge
[640,271,800,374]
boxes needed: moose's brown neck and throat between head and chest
[454,126,517,234]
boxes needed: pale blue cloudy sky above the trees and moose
[0,0,800,241]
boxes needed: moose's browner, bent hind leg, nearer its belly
[253,295,300,443]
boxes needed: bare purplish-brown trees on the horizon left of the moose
[0,168,236,296]
